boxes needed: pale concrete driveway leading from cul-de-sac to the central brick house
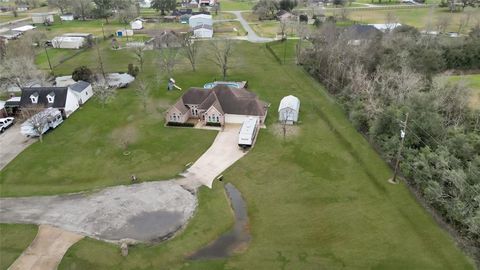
[180,125,247,188]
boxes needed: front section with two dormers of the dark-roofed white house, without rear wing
[20,87,80,118]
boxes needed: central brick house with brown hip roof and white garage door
[165,85,269,125]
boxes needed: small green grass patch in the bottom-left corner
[0,224,37,270]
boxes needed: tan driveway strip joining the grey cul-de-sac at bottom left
[8,225,83,270]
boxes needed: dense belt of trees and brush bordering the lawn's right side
[297,23,480,260]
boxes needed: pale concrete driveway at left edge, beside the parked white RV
[0,123,37,170]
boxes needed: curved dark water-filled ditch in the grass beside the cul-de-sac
[189,183,250,260]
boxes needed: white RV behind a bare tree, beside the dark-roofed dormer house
[20,108,63,137]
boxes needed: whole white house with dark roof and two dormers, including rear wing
[19,81,93,118]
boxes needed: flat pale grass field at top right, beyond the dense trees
[344,7,480,33]
